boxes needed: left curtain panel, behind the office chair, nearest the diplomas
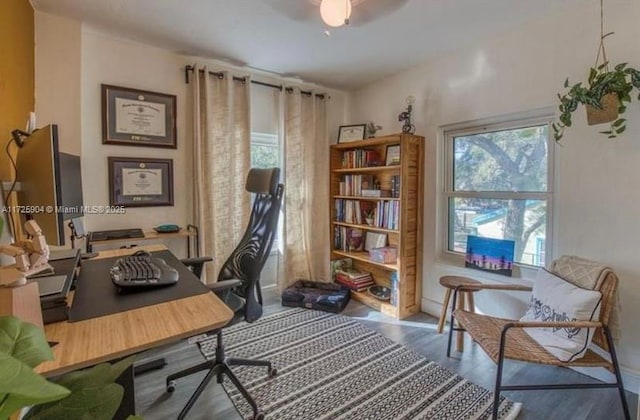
[191,66,251,282]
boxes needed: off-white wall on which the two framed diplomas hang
[36,12,346,260]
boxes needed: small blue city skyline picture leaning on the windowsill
[464,235,515,277]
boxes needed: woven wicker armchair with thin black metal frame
[447,257,631,420]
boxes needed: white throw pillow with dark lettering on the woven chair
[520,269,602,362]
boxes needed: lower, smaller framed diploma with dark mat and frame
[108,156,173,207]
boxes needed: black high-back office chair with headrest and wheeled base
[167,168,284,419]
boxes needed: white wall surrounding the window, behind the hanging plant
[350,0,640,392]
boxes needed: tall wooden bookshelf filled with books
[329,133,424,319]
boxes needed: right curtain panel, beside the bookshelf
[278,88,330,289]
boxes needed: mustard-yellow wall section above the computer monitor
[0,0,34,180]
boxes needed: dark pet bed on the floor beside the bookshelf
[282,280,351,313]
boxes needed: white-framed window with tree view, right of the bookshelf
[444,118,553,266]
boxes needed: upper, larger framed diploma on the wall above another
[102,85,178,149]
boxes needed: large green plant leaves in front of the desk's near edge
[0,316,140,420]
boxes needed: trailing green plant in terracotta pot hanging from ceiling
[552,0,640,141]
